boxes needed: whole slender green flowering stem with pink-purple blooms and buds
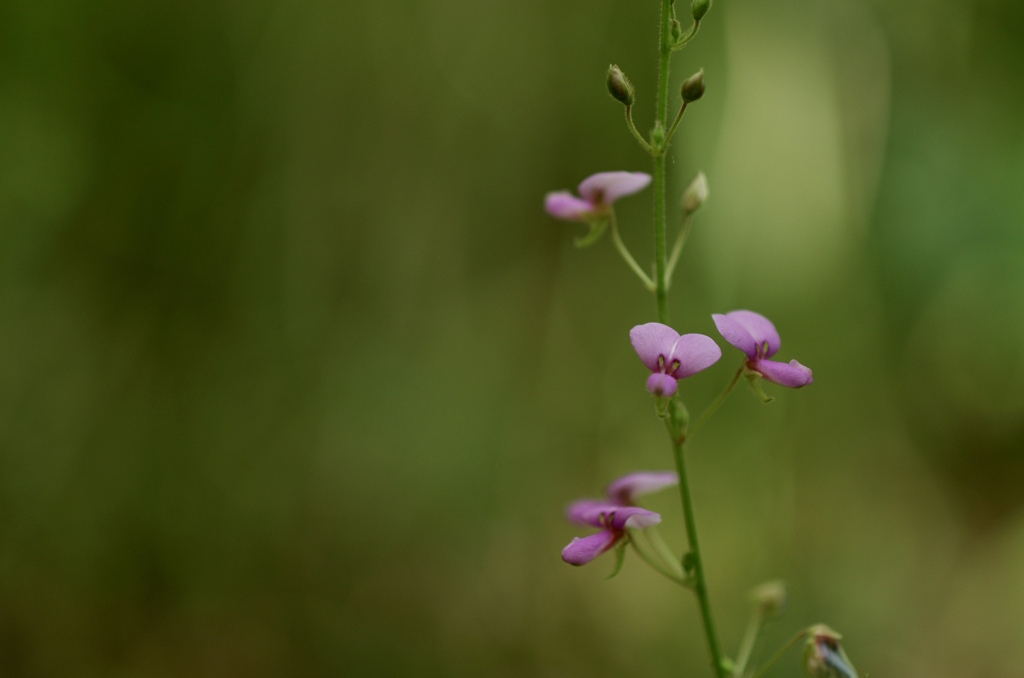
[544,0,839,663]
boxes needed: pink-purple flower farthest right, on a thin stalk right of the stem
[712,310,814,388]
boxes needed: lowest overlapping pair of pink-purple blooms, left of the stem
[562,471,679,565]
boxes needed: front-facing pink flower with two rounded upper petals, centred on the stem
[630,323,722,396]
